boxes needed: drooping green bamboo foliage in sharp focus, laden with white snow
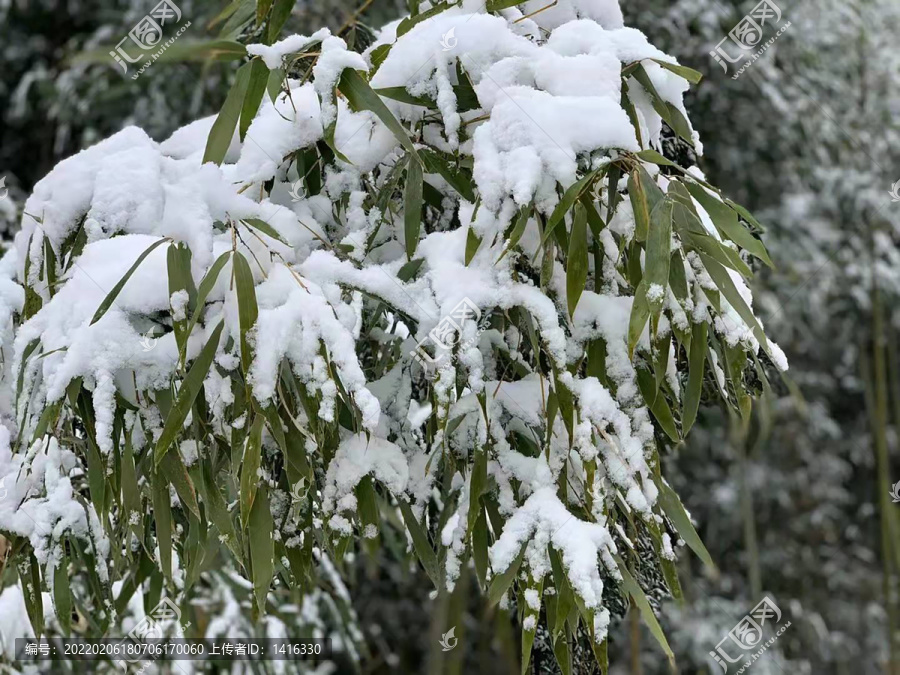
[0,0,787,667]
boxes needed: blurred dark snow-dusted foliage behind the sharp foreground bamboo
[0,0,900,675]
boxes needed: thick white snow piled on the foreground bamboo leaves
[0,0,787,639]
